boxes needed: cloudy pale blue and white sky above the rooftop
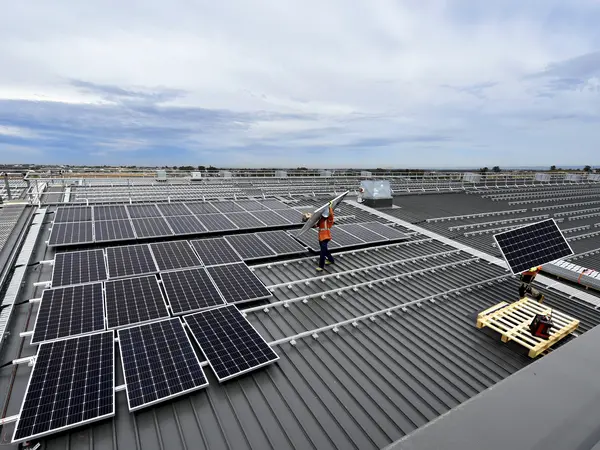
[0,0,600,167]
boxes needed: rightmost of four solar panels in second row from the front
[206,263,273,303]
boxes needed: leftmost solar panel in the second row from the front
[30,281,106,345]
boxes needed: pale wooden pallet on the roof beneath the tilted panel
[477,297,579,358]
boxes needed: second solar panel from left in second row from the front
[105,275,169,328]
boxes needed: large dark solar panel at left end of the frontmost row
[12,331,115,442]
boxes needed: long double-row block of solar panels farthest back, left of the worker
[48,199,302,247]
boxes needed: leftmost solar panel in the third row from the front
[52,250,106,287]
